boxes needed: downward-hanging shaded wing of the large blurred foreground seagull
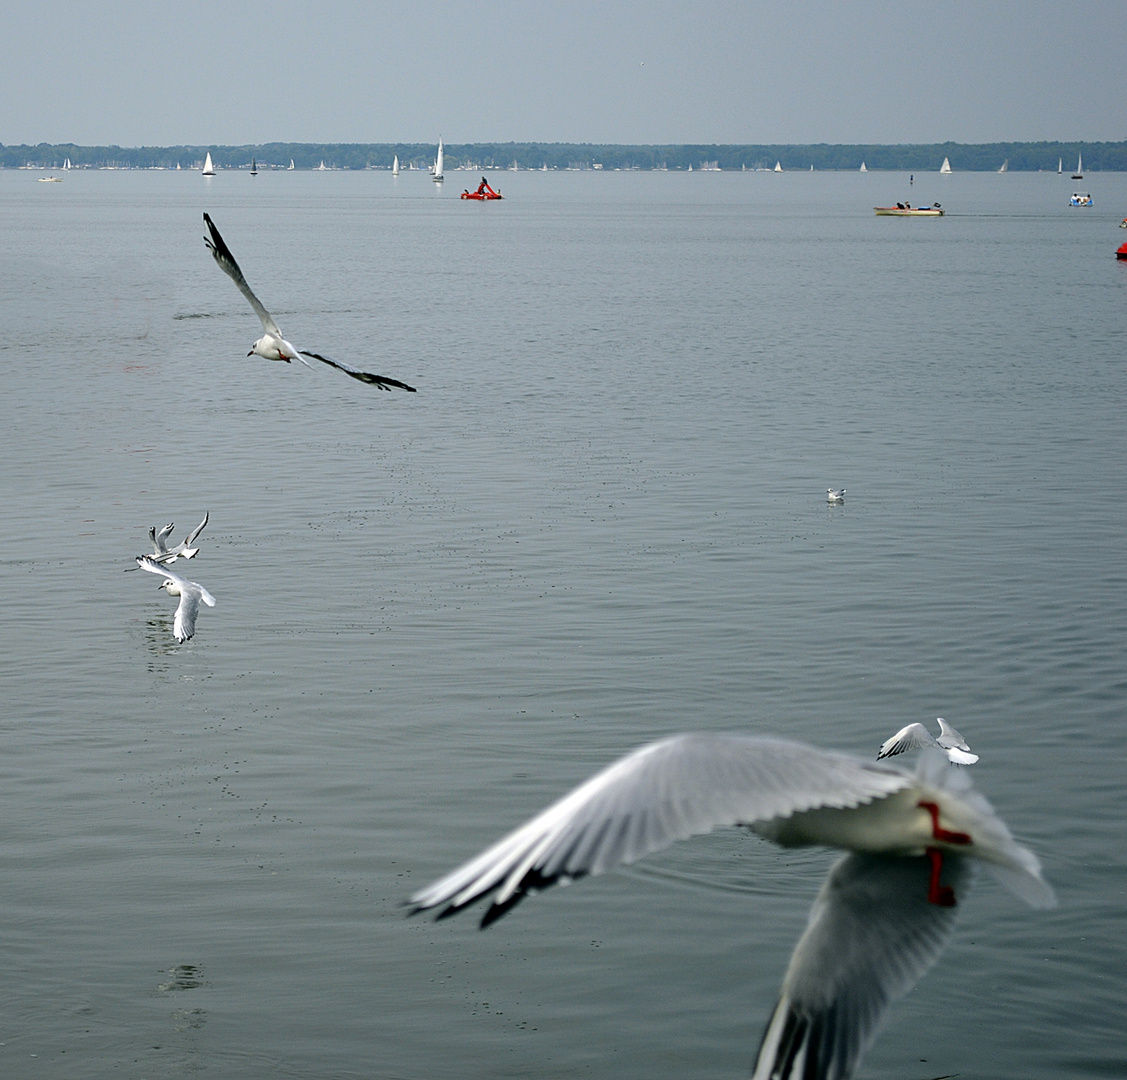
[752,853,971,1080]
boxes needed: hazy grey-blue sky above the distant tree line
[0,0,1127,147]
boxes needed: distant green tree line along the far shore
[0,142,1127,172]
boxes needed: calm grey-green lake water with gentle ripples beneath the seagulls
[0,164,1127,1080]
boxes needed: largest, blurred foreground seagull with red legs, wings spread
[407,733,1056,1080]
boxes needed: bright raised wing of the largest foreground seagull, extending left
[408,733,914,926]
